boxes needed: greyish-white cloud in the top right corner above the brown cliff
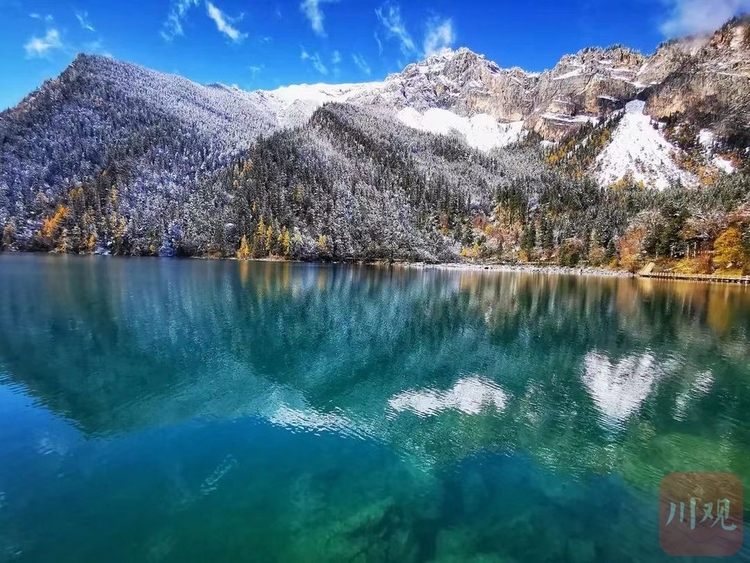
[660,0,750,37]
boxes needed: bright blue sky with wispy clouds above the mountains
[0,0,750,109]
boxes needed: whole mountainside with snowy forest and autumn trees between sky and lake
[0,20,750,273]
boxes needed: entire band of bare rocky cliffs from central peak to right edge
[350,18,750,147]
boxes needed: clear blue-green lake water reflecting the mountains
[0,255,750,562]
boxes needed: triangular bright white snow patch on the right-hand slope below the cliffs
[595,101,698,190]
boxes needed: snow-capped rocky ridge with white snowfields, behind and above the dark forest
[245,19,750,188]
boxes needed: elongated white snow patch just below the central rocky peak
[397,108,523,151]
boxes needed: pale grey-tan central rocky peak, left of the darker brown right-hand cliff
[350,47,644,140]
